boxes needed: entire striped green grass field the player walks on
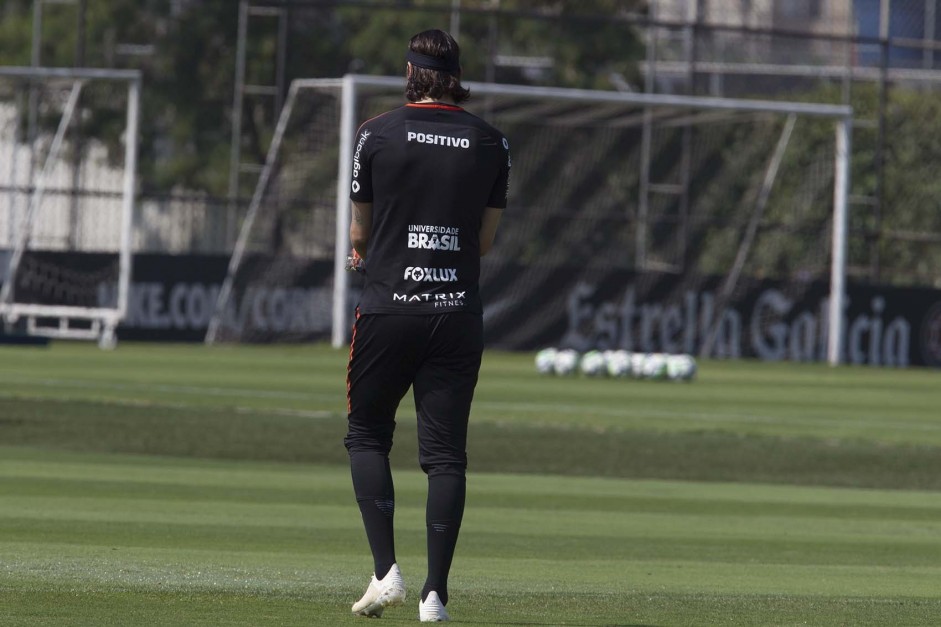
[0,343,941,626]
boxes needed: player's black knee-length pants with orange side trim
[345,312,483,475]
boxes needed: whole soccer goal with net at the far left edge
[0,67,141,347]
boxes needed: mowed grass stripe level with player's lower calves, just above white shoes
[7,512,941,569]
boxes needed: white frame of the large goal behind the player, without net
[206,74,853,365]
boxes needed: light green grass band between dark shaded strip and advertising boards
[0,343,941,446]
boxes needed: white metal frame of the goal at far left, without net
[0,67,141,348]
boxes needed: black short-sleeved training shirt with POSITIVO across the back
[350,103,510,314]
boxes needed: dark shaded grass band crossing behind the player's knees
[0,392,941,490]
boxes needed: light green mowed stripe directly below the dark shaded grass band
[9,447,941,521]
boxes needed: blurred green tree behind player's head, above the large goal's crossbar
[337,0,647,89]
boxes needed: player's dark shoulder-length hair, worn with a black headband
[405,29,470,103]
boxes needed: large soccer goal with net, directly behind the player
[206,75,852,363]
